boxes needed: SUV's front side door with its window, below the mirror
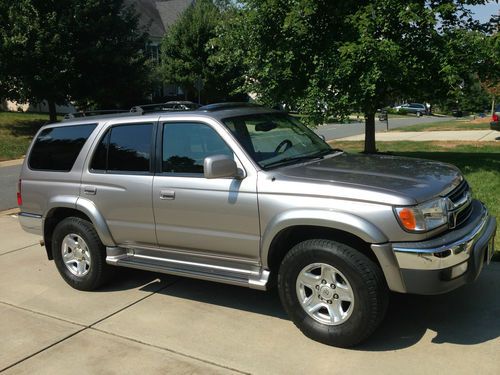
[153,121,260,261]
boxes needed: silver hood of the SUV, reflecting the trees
[274,153,463,204]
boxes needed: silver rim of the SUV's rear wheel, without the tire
[61,233,91,277]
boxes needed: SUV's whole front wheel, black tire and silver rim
[278,240,388,347]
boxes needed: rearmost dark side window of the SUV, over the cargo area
[29,124,97,172]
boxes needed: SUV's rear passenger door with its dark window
[81,122,157,246]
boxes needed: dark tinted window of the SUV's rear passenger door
[90,124,153,172]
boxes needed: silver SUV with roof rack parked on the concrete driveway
[18,104,496,347]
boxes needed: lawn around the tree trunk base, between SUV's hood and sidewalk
[330,141,500,261]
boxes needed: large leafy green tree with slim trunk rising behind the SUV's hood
[218,0,492,152]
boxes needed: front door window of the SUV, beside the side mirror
[162,123,233,173]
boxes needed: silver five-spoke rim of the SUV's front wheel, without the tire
[296,263,354,325]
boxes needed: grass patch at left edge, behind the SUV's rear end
[0,112,57,161]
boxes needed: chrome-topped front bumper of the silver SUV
[392,200,497,294]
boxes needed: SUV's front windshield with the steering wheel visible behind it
[222,113,332,168]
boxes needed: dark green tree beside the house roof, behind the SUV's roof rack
[160,0,242,102]
